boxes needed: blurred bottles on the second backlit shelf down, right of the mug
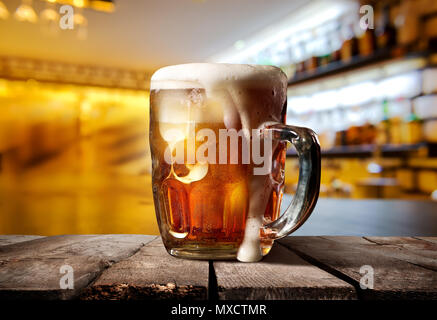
[306,100,437,149]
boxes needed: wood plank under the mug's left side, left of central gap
[80,238,209,300]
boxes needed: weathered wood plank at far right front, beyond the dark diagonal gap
[279,237,437,299]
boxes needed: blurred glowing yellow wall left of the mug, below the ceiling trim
[0,79,154,235]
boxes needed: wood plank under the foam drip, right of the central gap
[214,244,357,300]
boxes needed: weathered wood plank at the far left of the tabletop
[0,235,156,299]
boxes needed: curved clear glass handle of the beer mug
[262,123,321,240]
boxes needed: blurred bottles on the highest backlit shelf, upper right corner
[283,0,437,78]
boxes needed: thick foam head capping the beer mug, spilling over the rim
[150,63,287,130]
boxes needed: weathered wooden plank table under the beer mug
[0,235,437,301]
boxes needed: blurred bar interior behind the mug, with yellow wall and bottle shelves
[0,0,437,235]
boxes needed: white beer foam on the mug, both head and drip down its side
[150,63,287,262]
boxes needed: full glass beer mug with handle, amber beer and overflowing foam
[150,63,320,262]
